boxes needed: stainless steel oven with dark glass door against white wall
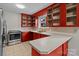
[8,30,21,45]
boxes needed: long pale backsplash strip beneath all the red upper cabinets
[21,27,79,33]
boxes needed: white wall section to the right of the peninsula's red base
[68,29,79,56]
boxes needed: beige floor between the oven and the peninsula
[3,42,31,56]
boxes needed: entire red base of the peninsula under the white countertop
[32,42,68,56]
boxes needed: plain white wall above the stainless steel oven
[4,11,21,30]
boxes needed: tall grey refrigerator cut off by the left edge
[0,9,3,56]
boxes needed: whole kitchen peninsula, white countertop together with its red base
[29,31,72,56]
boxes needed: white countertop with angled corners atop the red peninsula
[29,31,72,54]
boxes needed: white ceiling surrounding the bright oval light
[0,3,51,15]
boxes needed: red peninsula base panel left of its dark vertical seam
[32,46,62,56]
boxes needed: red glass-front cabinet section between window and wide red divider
[47,4,60,27]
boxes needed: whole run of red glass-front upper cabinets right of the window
[46,3,79,27]
